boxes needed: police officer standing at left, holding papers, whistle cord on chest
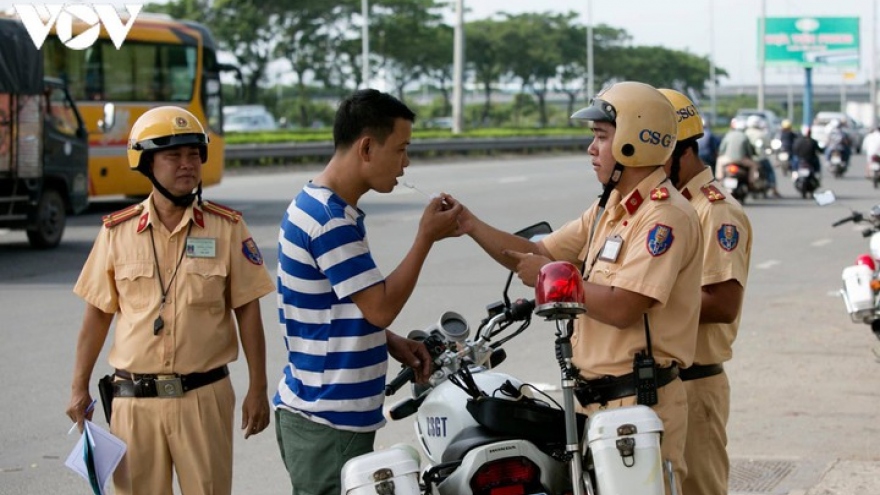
[67,107,274,495]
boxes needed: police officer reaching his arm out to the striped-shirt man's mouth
[460,82,702,493]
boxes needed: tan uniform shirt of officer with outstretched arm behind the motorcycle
[541,168,703,379]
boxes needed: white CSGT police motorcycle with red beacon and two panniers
[341,223,669,495]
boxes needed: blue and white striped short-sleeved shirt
[273,184,388,431]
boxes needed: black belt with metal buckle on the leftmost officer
[113,365,229,398]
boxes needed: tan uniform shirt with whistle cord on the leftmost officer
[73,197,275,374]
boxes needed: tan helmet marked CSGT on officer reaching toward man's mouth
[571,81,676,167]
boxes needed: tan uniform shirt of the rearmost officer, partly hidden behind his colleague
[682,168,752,364]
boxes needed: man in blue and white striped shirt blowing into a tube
[273,90,462,495]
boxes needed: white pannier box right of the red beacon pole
[587,406,665,495]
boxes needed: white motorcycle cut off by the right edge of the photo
[815,191,880,339]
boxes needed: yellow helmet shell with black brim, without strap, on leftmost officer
[128,106,208,170]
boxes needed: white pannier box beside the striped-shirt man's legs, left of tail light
[341,445,421,495]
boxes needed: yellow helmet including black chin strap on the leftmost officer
[128,106,208,206]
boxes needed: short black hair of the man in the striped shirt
[333,89,416,150]
